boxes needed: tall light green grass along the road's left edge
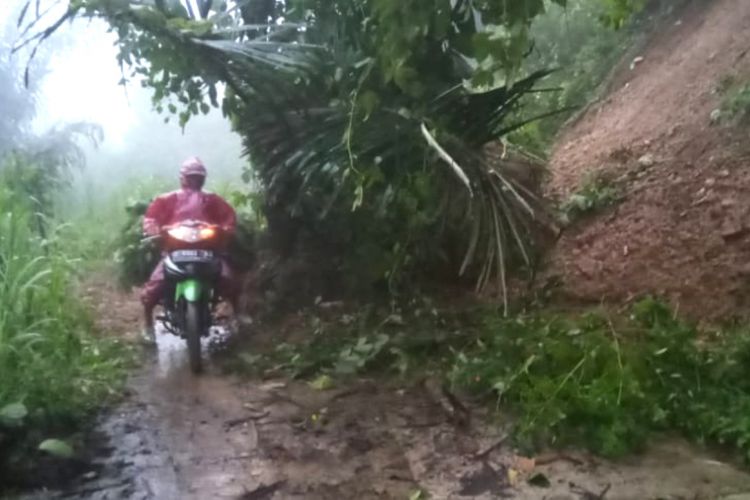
[0,188,128,434]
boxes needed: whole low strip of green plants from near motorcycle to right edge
[238,297,750,460]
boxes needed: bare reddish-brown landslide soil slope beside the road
[548,0,750,320]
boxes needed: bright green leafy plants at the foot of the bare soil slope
[449,298,750,458]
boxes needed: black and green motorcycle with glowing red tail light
[157,221,222,373]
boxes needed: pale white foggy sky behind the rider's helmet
[0,0,246,203]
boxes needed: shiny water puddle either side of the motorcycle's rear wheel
[156,322,230,378]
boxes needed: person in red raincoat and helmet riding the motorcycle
[141,157,240,344]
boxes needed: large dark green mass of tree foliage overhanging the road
[19,0,644,304]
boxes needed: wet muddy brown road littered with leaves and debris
[22,280,750,500]
